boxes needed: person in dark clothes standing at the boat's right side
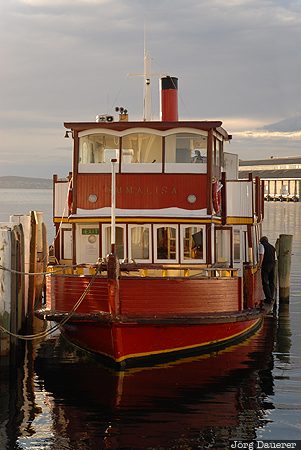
[259,236,277,303]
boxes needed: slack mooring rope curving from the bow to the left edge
[0,265,100,341]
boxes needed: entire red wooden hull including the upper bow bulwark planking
[40,275,263,366]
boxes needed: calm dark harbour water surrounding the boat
[0,191,301,450]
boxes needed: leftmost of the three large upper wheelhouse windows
[79,133,119,172]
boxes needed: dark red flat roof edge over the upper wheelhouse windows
[64,121,232,140]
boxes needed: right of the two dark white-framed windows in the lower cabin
[181,225,206,263]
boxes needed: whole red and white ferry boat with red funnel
[36,72,268,367]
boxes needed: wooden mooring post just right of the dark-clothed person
[278,234,293,303]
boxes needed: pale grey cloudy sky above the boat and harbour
[0,0,301,178]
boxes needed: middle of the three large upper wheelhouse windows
[121,133,162,172]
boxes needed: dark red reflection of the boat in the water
[36,319,273,449]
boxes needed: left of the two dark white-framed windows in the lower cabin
[154,225,178,262]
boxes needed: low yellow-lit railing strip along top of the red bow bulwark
[47,262,239,279]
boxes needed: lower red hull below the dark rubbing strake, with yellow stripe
[60,317,261,366]
